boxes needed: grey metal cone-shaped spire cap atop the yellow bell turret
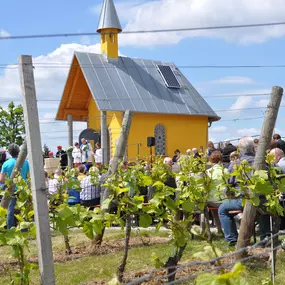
[97,0,122,33]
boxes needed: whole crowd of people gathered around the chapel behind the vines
[0,134,285,245]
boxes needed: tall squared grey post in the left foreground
[19,55,55,285]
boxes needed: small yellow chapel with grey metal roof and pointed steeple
[56,0,220,163]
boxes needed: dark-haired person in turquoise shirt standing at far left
[0,143,30,229]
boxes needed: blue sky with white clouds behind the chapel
[0,0,285,151]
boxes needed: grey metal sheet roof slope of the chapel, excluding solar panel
[75,52,220,121]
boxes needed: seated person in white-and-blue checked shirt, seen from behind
[80,170,101,210]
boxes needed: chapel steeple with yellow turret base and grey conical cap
[97,0,122,58]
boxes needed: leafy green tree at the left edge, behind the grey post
[0,101,25,146]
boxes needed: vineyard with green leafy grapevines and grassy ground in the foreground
[0,152,285,285]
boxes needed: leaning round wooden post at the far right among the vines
[236,86,283,260]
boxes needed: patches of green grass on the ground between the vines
[0,230,285,285]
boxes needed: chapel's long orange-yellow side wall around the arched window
[125,113,208,160]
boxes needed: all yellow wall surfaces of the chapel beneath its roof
[88,99,208,160]
